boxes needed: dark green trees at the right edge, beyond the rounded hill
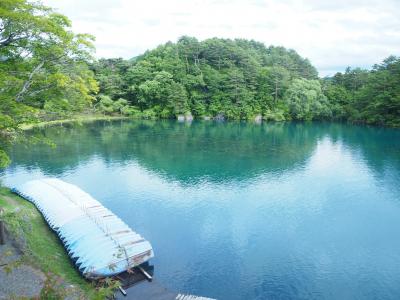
[323,56,400,127]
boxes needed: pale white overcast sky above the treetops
[43,0,400,76]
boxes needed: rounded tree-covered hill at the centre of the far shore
[93,37,324,120]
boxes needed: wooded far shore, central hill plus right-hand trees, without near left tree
[92,36,400,126]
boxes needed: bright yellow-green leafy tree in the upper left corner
[0,0,98,166]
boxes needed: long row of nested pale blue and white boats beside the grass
[13,178,154,279]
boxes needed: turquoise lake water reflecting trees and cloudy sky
[2,121,400,300]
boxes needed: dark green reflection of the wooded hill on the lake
[5,121,321,182]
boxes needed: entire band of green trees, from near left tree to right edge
[0,0,400,166]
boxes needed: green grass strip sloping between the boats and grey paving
[0,188,96,298]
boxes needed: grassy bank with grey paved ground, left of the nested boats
[0,186,98,299]
